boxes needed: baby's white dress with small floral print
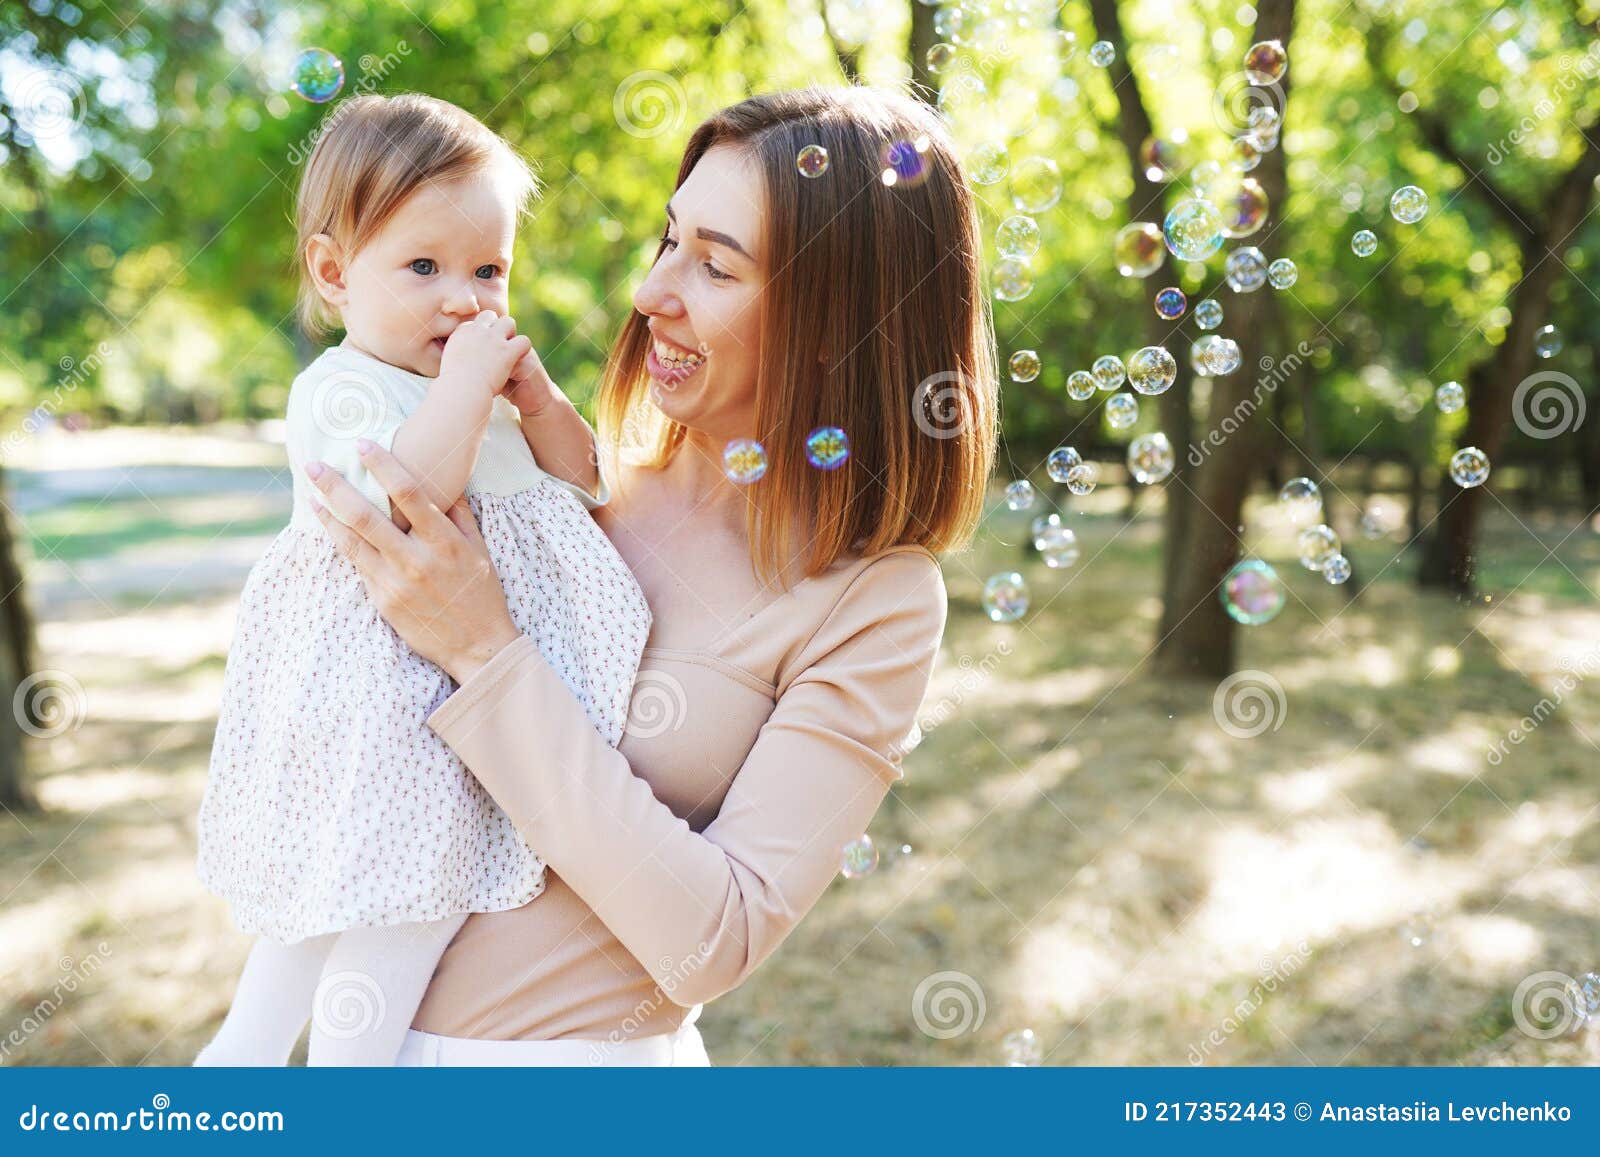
[198,346,650,943]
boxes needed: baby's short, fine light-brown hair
[294,93,539,336]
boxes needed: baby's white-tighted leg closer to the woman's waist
[306,914,467,1066]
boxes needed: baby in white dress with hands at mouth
[195,94,650,1064]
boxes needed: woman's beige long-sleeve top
[413,547,946,1040]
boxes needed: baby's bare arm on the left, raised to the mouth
[390,310,533,530]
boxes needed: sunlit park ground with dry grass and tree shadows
[0,429,1600,1066]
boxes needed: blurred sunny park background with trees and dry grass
[0,0,1600,1064]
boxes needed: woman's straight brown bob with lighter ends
[595,88,998,579]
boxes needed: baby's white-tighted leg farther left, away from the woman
[195,933,338,1066]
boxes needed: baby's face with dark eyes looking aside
[339,173,517,378]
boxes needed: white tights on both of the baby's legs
[195,914,467,1066]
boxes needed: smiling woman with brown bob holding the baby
[300,88,995,1064]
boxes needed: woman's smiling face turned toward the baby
[634,146,766,440]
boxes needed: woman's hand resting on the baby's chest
[306,445,520,683]
